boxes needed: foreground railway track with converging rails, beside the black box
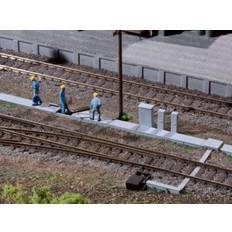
[0,114,232,189]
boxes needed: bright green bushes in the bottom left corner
[2,184,90,204]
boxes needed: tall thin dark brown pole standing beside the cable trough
[118,30,123,119]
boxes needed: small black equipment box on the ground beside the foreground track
[126,171,151,191]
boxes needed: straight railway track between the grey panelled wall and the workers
[0,53,232,120]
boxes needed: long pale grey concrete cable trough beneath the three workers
[0,93,229,154]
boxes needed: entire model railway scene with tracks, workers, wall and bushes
[0,30,232,203]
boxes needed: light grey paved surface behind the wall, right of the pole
[123,34,232,84]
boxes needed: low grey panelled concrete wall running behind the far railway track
[0,37,232,97]
